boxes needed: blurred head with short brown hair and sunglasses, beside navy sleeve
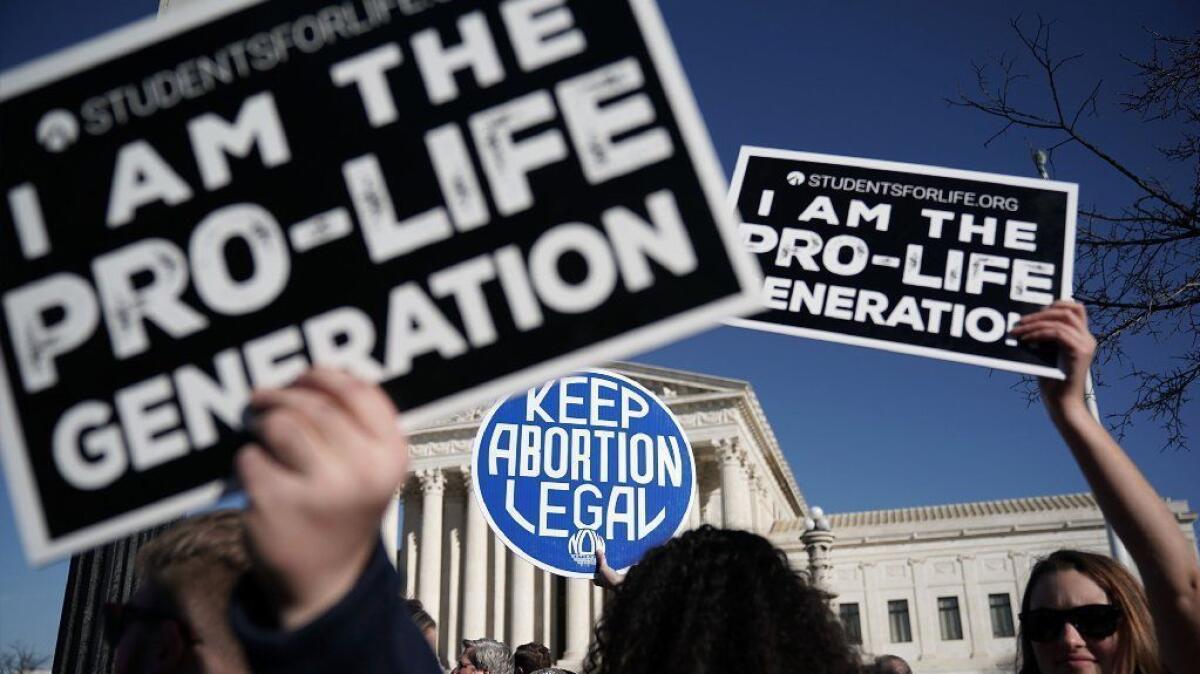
[104,511,250,674]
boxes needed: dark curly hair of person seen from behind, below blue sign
[583,525,860,674]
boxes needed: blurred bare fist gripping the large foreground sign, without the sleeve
[238,368,408,628]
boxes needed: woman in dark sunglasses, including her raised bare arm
[1013,301,1200,674]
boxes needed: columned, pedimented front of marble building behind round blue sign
[384,363,808,667]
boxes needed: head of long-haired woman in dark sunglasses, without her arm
[1018,550,1163,674]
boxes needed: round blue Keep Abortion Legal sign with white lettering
[470,369,696,578]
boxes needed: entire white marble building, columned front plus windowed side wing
[384,363,1196,674]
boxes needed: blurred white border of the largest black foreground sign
[0,0,762,566]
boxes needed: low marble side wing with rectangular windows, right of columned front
[769,494,1196,674]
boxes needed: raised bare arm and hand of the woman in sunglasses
[1013,301,1200,674]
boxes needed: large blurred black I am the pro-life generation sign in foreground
[0,0,757,561]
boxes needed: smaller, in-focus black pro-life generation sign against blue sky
[730,148,1078,379]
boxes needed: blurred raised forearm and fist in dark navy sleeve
[230,368,440,674]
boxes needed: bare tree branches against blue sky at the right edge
[947,17,1200,449]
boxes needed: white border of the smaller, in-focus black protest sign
[725,145,1079,379]
